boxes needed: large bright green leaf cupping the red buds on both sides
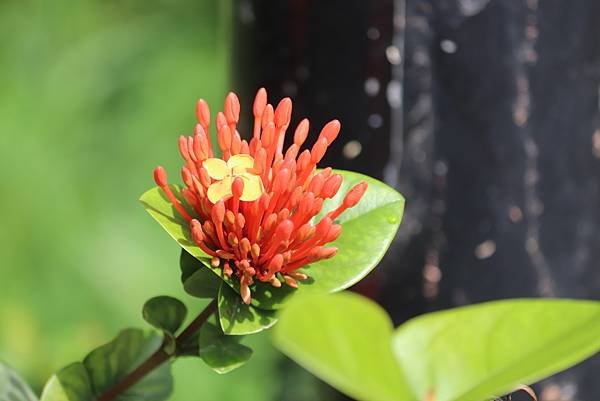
[140,170,404,309]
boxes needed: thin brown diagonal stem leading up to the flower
[96,299,217,401]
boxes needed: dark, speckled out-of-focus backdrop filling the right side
[232,0,600,401]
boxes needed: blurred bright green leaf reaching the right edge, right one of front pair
[393,299,600,401]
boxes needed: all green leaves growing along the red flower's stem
[1,171,404,401]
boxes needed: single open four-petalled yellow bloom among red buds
[202,154,264,203]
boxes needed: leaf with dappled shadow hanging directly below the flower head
[219,285,277,335]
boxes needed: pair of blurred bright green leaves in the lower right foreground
[274,293,600,401]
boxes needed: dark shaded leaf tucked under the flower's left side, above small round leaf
[179,249,223,298]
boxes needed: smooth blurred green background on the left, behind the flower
[0,0,314,401]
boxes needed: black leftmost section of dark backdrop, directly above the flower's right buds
[233,0,398,177]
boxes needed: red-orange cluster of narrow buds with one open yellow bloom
[154,88,367,304]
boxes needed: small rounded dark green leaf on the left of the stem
[142,295,187,354]
